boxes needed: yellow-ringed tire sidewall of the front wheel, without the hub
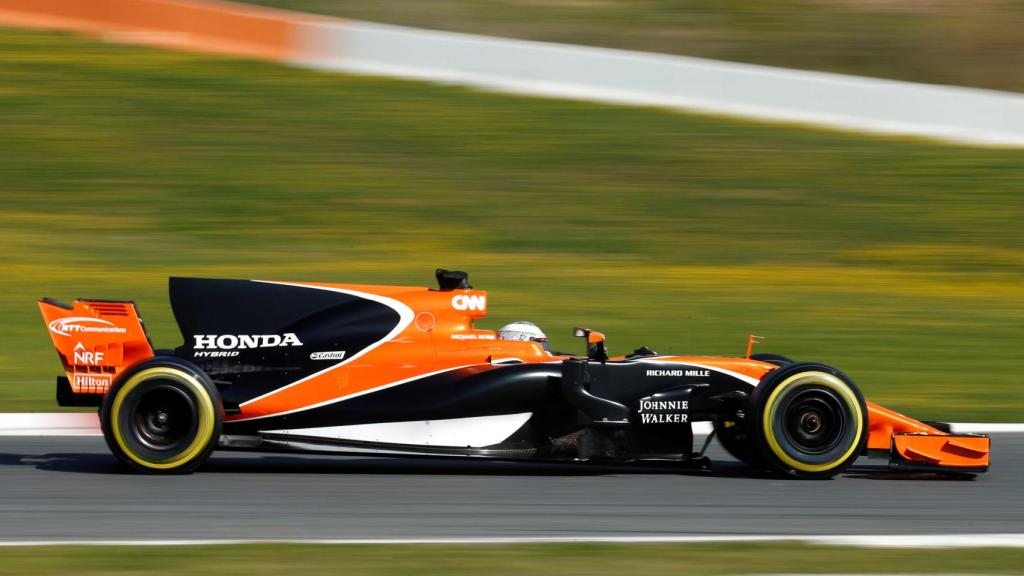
[750,362,868,479]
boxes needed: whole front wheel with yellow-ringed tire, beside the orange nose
[752,363,867,479]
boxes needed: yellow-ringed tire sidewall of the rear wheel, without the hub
[99,357,223,474]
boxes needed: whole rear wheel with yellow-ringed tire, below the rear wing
[99,357,223,474]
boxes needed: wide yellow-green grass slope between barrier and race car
[0,30,1024,420]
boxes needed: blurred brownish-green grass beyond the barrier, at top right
[248,0,1024,91]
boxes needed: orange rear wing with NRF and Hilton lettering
[39,298,153,393]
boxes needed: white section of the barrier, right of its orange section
[293,20,1024,147]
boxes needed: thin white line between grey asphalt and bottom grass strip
[0,534,1024,548]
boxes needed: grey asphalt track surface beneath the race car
[0,434,1024,541]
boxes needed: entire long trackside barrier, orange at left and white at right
[0,0,1024,148]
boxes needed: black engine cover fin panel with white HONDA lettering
[170,278,400,405]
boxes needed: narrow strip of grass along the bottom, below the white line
[0,543,1024,576]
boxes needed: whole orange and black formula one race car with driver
[39,270,989,479]
